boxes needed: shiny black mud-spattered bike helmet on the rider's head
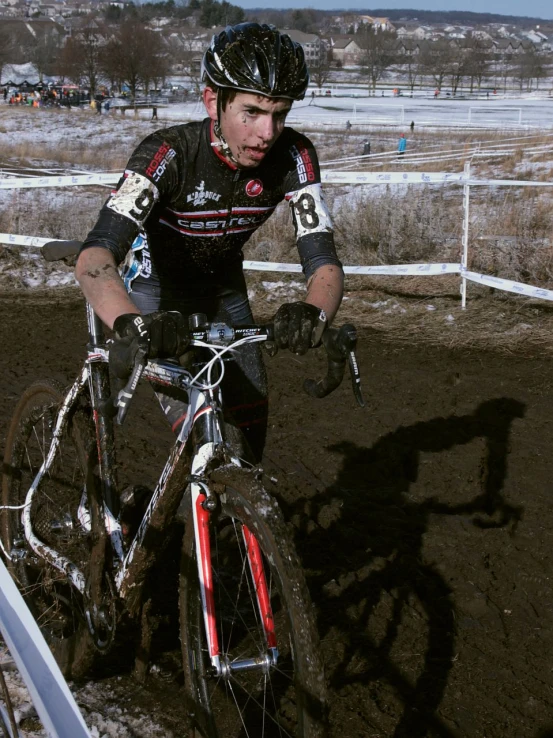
[202,23,309,100]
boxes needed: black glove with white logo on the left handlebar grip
[109,311,190,379]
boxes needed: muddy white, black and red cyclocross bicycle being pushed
[2,242,363,738]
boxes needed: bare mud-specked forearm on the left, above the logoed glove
[75,246,140,328]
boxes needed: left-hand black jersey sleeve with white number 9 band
[81,131,178,264]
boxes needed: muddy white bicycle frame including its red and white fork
[17,305,278,677]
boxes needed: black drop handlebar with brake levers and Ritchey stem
[113,316,365,425]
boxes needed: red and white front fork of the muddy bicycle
[190,412,278,679]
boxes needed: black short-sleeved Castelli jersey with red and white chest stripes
[83,118,341,292]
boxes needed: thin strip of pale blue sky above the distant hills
[236,0,553,20]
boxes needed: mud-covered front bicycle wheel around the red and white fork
[179,467,327,738]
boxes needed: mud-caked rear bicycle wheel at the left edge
[2,381,95,679]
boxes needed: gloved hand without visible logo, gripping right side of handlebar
[269,302,326,354]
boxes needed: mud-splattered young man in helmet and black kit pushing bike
[76,23,343,458]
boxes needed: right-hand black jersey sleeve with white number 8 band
[285,133,342,279]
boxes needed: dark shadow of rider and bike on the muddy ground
[276,398,525,738]
